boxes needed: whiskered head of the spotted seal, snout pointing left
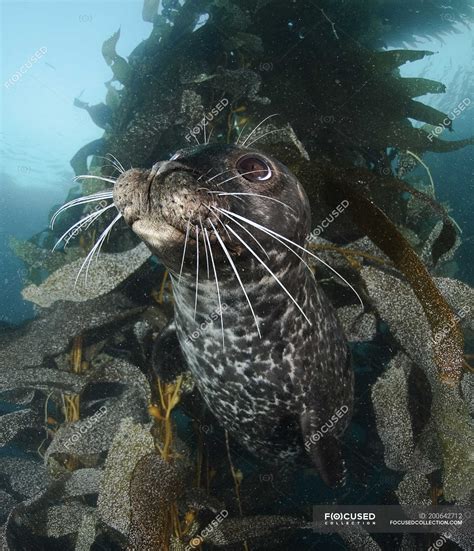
[114,145,310,271]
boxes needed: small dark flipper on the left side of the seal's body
[151,321,186,383]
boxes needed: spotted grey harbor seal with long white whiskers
[113,144,354,486]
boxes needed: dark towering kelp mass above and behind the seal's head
[65,0,472,177]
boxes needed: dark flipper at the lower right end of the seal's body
[301,412,346,487]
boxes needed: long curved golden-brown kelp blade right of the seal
[326,169,464,385]
